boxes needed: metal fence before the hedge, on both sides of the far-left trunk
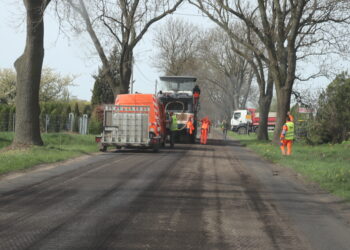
[0,113,90,134]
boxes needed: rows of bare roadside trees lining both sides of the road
[2,0,350,145]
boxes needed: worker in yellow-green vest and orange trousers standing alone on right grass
[280,112,294,155]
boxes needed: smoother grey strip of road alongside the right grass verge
[230,139,350,249]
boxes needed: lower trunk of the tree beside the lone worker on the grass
[273,87,292,143]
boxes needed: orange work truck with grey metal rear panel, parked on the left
[97,94,166,151]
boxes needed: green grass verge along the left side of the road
[0,133,98,174]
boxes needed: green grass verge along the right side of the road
[230,132,350,201]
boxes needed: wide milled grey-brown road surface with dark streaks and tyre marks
[0,132,350,250]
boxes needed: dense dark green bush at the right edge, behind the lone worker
[308,73,350,144]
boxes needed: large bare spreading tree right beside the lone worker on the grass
[190,0,350,141]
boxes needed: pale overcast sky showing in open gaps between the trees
[0,0,349,101]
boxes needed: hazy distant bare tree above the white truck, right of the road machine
[199,29,253,113]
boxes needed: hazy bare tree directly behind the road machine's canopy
[153,18,199,75]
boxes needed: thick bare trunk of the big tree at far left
[13,0,48,145]
